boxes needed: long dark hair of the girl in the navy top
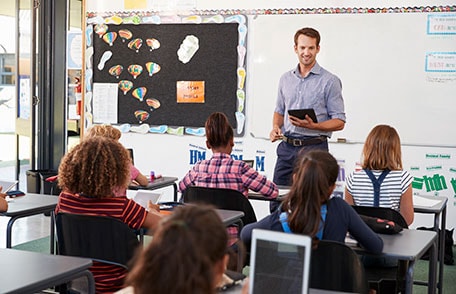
[283,150,339,237]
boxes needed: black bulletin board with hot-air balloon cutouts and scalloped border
[85,15,247,135]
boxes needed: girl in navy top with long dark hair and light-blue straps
[241,150,383,253]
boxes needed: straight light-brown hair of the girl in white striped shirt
[362,125,402,170]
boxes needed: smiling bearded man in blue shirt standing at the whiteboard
[269,28,345,187]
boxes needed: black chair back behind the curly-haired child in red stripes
[56,213,139,269]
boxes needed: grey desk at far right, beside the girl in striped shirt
[413,195,448,294]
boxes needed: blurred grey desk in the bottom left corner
[0,249,95,293]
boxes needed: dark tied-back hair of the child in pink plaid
[205,112,234,148]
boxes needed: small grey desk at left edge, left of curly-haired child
[0,193,59,253]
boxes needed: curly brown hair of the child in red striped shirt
[58,137,130,198]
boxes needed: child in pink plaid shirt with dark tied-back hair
[179,112,279,198]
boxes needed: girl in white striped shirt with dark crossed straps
[345,125,414,225]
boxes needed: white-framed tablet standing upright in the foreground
[249,229,312,294]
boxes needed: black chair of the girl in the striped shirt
[352,205,408,294]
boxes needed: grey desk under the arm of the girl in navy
[347,229,437,293]
